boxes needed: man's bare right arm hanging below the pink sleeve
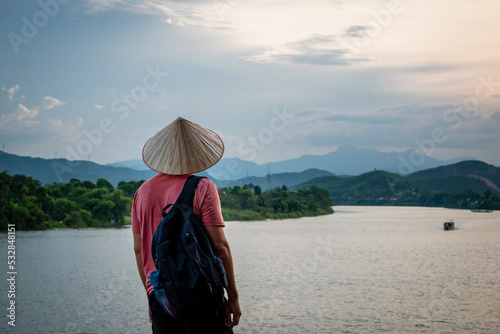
[205,226,241,328]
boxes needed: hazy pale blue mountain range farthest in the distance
[108,146,475,181]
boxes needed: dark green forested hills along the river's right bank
[292,161,500,207]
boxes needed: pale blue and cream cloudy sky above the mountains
[0,0,500,165]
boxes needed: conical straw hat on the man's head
[142,117,224,175]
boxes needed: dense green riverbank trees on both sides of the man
[0,172,333,231]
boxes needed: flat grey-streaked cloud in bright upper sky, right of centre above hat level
[243,35,372,66]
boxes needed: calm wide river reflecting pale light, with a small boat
[0,206,500,334]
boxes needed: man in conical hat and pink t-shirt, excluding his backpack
[132,117,241,334]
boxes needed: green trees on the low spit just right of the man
[219,184,333,221]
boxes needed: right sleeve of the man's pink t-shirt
[193,179,225,226]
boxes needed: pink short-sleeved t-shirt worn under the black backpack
[132,173,225,295]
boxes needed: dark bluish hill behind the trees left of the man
[0,151,156,187]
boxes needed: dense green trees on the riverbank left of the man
[0,172,141,231]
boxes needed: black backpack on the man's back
[151,175,227,318]
